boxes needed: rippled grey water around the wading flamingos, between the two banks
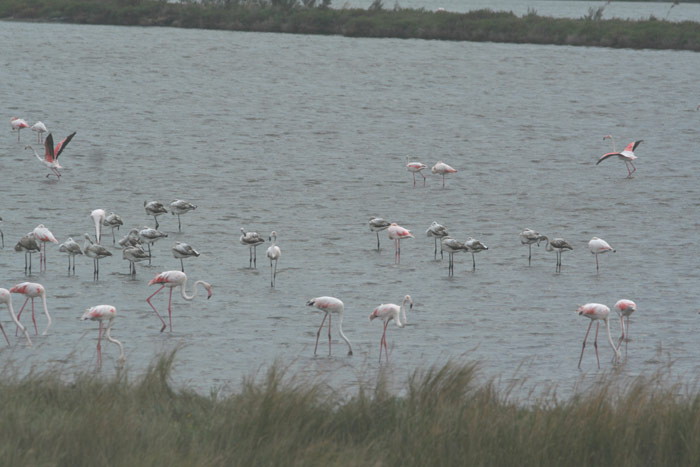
[0,23,700,395]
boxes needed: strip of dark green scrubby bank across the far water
[0,0,700,52]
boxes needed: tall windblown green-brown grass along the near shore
[0,353,700,466]
